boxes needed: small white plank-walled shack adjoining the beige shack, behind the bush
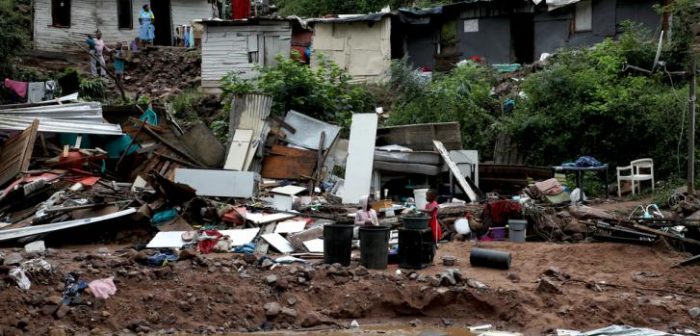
[202,18,307,92]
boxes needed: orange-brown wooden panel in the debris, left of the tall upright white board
[260,146,316,180]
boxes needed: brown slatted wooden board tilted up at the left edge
[0,120,39,185]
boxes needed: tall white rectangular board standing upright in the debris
[341,113,378,203]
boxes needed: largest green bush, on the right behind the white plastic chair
[501,24,687,176]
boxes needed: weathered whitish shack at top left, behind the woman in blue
[33,0,213,53]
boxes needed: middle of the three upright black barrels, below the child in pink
[360,226,389,269]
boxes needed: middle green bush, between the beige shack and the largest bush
[388,60,500,157]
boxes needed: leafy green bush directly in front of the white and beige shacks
[222,55,374,126]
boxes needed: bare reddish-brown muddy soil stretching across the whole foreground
[0,242,700,335]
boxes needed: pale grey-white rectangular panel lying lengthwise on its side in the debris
[175,168,260,198]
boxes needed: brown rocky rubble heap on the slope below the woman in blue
[124,46,202,99]
